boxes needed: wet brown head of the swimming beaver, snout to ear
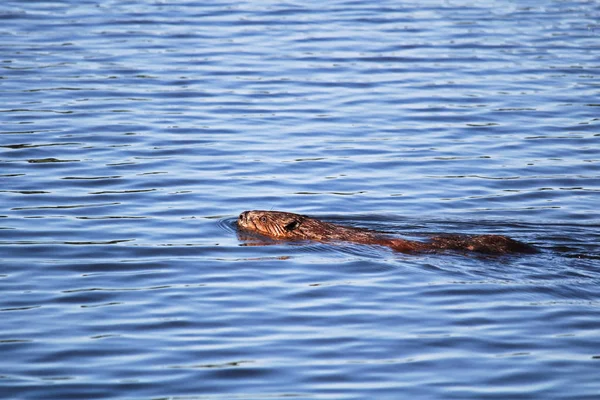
[238,210,308,239]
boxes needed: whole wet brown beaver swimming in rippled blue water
[238,210,536,254]
